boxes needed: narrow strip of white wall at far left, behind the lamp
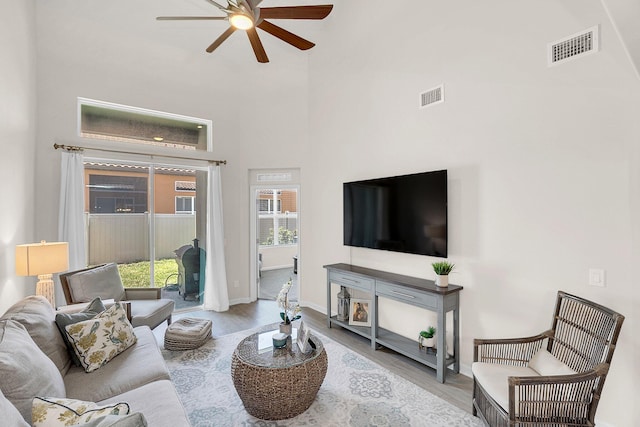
[0,0,36,313]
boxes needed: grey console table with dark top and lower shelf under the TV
[324,264,462,383]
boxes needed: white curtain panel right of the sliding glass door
[204,165,229,311]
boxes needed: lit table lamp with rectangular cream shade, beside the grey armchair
[16,240,69,307]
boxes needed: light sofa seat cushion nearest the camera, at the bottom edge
[98,382,191,427]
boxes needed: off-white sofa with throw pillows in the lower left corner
[0,296,190,427]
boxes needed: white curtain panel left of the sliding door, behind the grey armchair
[58,151,87,270]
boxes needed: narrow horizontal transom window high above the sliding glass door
[78,98,211,151]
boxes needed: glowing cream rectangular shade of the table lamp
[16,240,69,276]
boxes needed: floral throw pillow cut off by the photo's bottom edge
[31,397,129,427]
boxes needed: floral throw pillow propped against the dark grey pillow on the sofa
[65,303,137,372]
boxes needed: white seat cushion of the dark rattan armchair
[471,362,539,413]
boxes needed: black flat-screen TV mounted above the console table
[343,170,447,258]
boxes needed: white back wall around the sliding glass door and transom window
[36,0,307,308]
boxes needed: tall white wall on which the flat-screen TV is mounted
[301,0,640,427]
